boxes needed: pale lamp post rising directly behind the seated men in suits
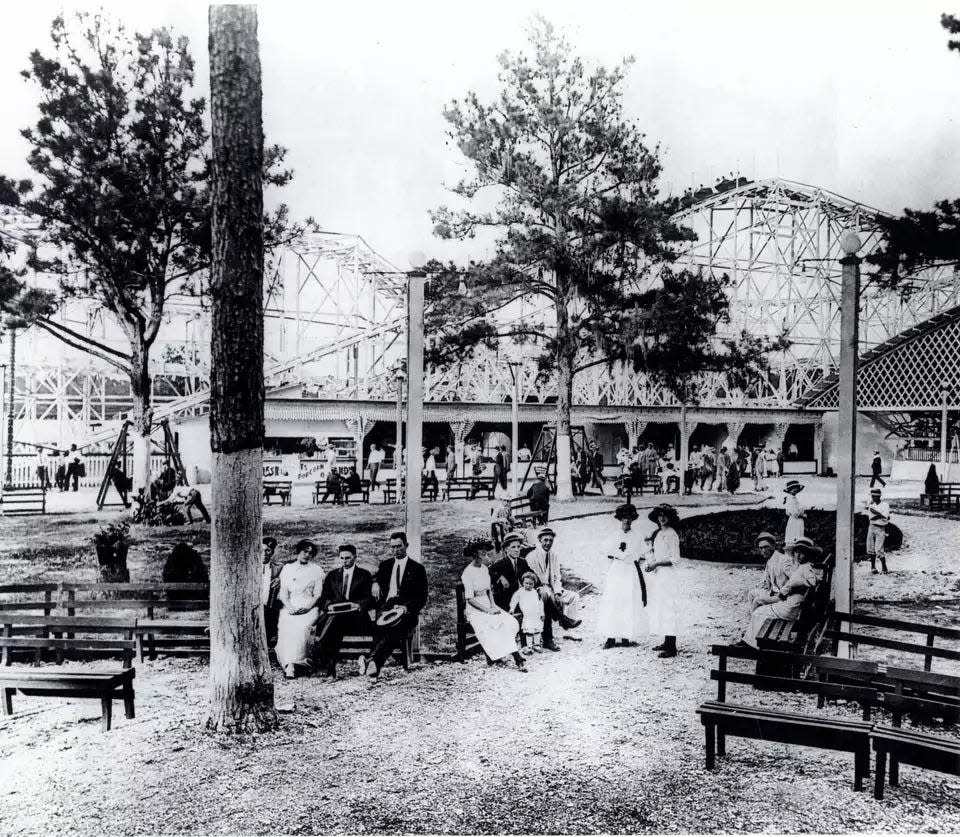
[406,253,427,560]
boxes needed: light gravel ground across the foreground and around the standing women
[0,496,960,835]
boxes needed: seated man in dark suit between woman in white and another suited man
[315,543,376,678]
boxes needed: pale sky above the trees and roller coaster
[0,0,960,268]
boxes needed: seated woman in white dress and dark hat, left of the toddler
[460,538,527,671]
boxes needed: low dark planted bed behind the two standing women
[680,508,903,564]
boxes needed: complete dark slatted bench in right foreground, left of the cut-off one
[697,646,880,791]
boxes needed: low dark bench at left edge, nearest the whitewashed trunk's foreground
[0,668,136,732]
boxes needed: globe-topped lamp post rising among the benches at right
[834,230,861,657]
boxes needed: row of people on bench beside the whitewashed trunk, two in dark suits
[262,532,428,680]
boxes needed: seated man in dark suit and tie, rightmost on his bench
[361,532,427,679]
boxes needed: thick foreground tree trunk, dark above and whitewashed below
[207,6,277,732]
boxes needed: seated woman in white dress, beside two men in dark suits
[277,540,323,680]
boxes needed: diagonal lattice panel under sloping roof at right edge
[802,306,960,413]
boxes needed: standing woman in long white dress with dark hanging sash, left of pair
[597,503,649,649]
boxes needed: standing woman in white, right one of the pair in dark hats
[643,503,680,657]
